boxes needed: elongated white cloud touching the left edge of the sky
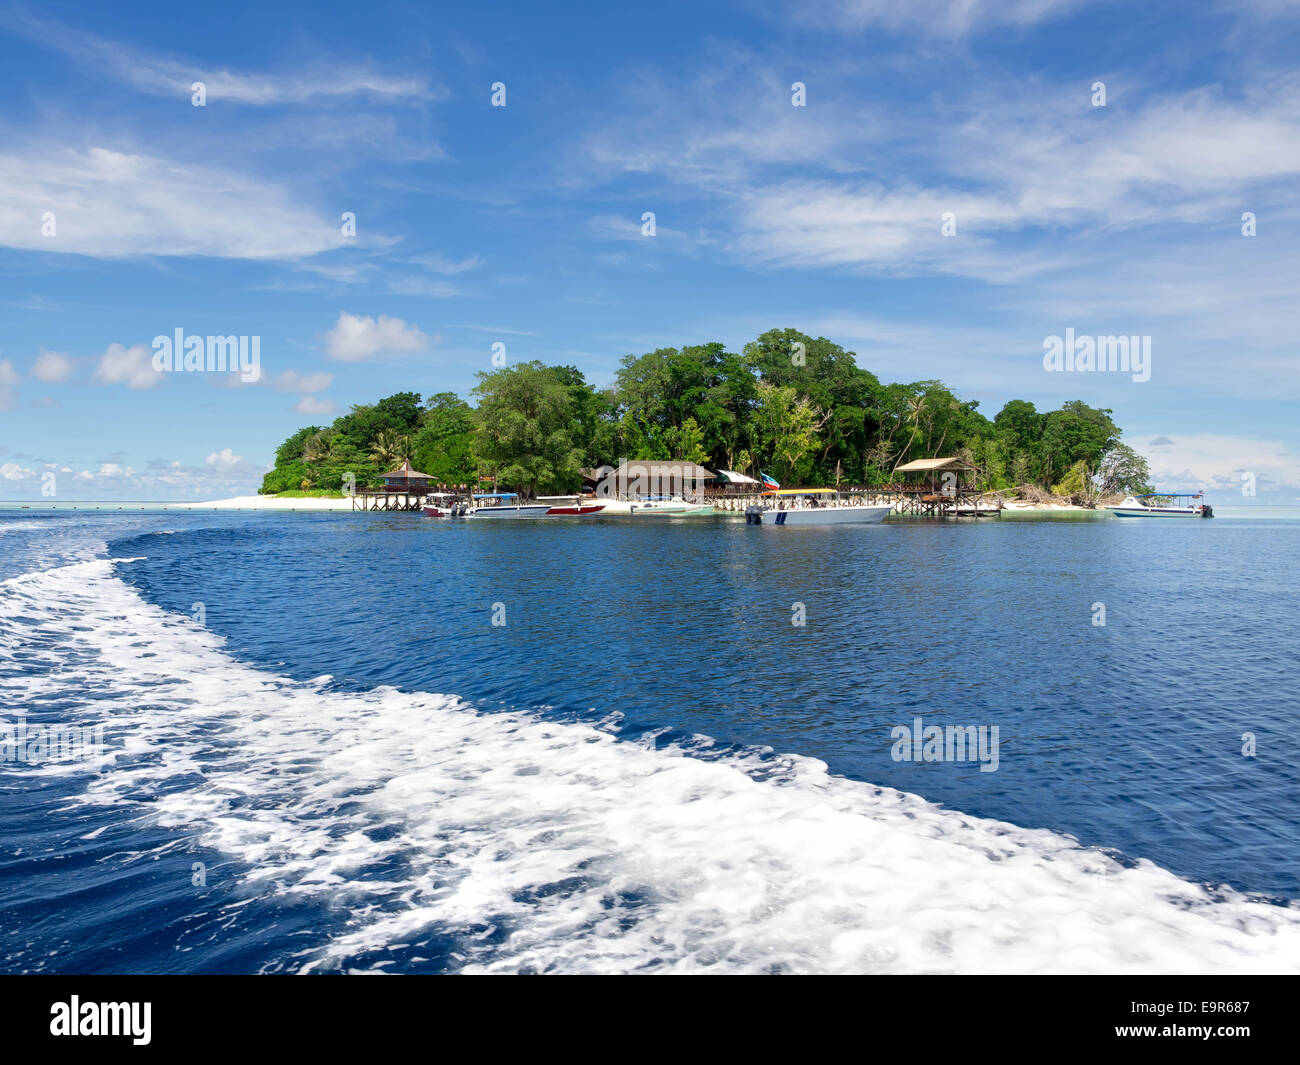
[0,147,346,260]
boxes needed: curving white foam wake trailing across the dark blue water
[0,560,1300,973]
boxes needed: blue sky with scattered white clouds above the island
[0,0,1300,503]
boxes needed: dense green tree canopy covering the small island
[263,329,1147,494]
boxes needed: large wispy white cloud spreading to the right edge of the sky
[579,60,1300,283]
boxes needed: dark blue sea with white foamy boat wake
[0,508,1300,973]
